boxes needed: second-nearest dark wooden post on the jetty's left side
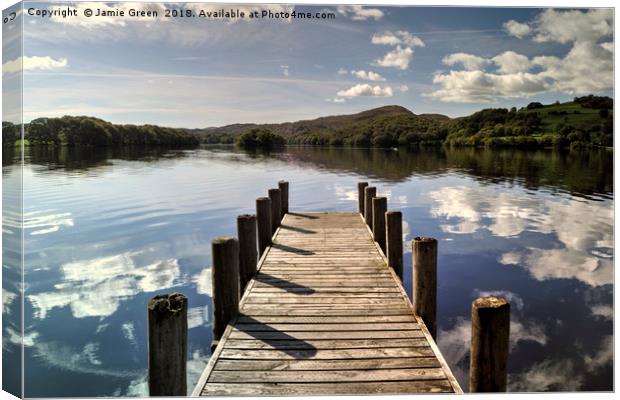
[211,236,239,341]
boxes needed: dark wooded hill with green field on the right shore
[445,95,613,148]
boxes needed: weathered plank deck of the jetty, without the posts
[193,212,462,396]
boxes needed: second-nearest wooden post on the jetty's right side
[412,237,437,339]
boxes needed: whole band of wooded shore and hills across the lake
[2,95,613,148]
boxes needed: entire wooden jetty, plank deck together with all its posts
[148,181,510,396]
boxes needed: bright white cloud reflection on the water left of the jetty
[28,253,180,319]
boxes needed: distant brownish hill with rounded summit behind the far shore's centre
[192,105,450,146]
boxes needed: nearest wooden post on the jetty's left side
[148,293,187,397]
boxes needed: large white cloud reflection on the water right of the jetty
[429,187,613,286]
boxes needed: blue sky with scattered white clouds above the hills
[3,2,613,128]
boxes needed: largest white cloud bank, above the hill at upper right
[426,9,613,103]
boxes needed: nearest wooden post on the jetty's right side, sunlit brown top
[469,297,510,393]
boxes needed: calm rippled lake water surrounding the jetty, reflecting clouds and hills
[2,147,614,397]
